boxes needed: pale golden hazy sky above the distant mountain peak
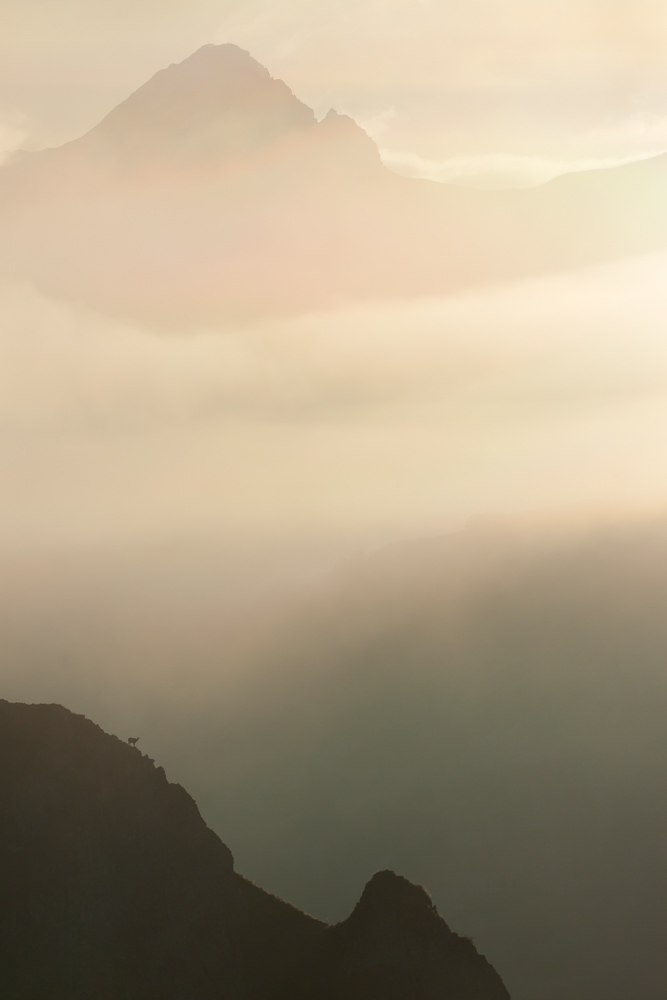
[0,0,667,179]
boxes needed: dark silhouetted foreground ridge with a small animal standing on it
[0,700,509,1000]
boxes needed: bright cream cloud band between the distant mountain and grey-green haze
[0,257,667,538]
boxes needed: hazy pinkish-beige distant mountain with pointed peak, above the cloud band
[0,45,667,326]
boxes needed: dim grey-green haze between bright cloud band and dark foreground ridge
[0,524,667,1000]
